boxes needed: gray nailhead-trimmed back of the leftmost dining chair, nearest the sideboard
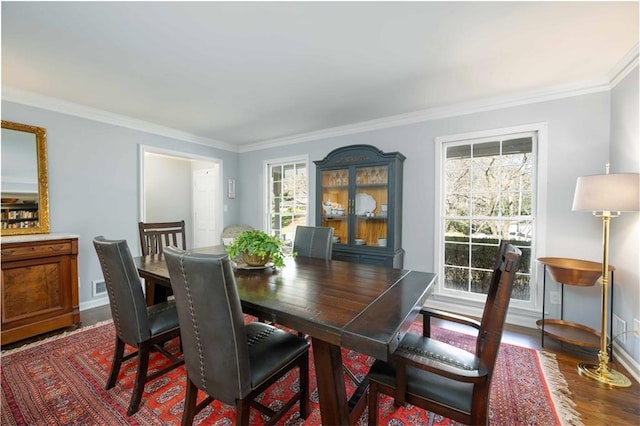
[93,236,151,347]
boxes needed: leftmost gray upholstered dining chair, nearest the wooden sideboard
[93,236,184,416]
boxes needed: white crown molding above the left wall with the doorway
[2,86,238,152]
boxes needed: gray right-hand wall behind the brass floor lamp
[608,66,640,362]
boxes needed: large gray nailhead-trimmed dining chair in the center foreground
[164,247,309,425]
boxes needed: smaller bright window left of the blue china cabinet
[266,158,309,250]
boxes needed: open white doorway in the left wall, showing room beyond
[140,146,223,248]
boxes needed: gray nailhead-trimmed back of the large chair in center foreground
[164,247,251,405]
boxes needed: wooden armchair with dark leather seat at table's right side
[367,244,521,425]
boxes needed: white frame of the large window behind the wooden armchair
[434,123,548,316]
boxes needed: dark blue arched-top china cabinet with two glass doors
[314,145,405,268]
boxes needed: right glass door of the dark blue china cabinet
[353,165,389,247]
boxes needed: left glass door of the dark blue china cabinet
[321,168,351,244]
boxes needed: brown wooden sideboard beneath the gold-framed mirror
[0,234,80,345]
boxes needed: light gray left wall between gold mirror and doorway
[2,101,238,309]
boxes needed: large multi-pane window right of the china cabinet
[438,131,538,304]
